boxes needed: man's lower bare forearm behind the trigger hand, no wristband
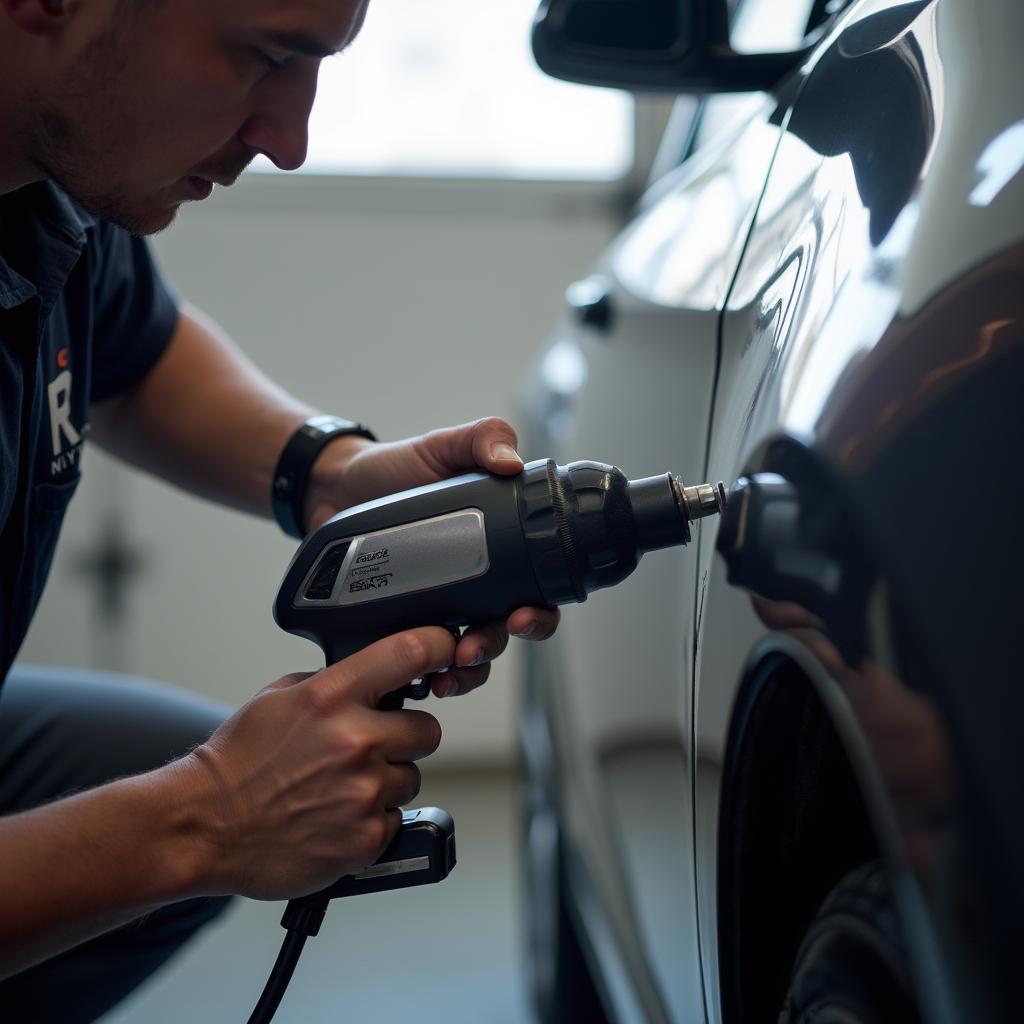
[0,762,212,977]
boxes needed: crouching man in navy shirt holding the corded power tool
[0,0,557,1022]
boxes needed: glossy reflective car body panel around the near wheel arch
[695,0,1024,1020]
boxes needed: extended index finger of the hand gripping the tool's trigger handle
[305,626,455,711]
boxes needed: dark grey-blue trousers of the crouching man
[0,666,234,1024]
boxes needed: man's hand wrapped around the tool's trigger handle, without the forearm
[182,627,455,899]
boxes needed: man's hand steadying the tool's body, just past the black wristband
[306,417,558,696]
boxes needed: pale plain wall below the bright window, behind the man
[23,179,613,762]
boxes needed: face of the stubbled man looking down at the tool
[30,0,368,234]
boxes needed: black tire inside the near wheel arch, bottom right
[778,861,922,1024]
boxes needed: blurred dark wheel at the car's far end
[525,813,606,1024]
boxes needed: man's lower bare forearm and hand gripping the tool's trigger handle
[0,627,455,974]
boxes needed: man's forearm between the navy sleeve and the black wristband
[91,299,315,515]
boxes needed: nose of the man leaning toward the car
[239,61,318,171]
